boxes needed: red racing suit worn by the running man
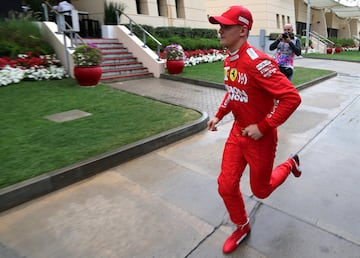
[215,42,301,225]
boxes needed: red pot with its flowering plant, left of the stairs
[72,44,102,86]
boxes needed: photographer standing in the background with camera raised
[269,23,301,81]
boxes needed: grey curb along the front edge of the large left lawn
[0,110,209,212]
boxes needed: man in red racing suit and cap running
[208,6,301,253]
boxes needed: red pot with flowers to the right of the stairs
[164,43,185,74]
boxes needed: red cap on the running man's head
[209,5,253,30]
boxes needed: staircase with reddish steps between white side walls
[83,38,153,82]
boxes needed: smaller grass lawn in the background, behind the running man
[175,62,332,85]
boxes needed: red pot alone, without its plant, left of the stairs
[74,66,102,86]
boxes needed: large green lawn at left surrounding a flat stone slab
[0,79,201,188]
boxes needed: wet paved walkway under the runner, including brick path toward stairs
[0,59,360,258]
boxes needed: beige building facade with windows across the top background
[72,0,360,38]
